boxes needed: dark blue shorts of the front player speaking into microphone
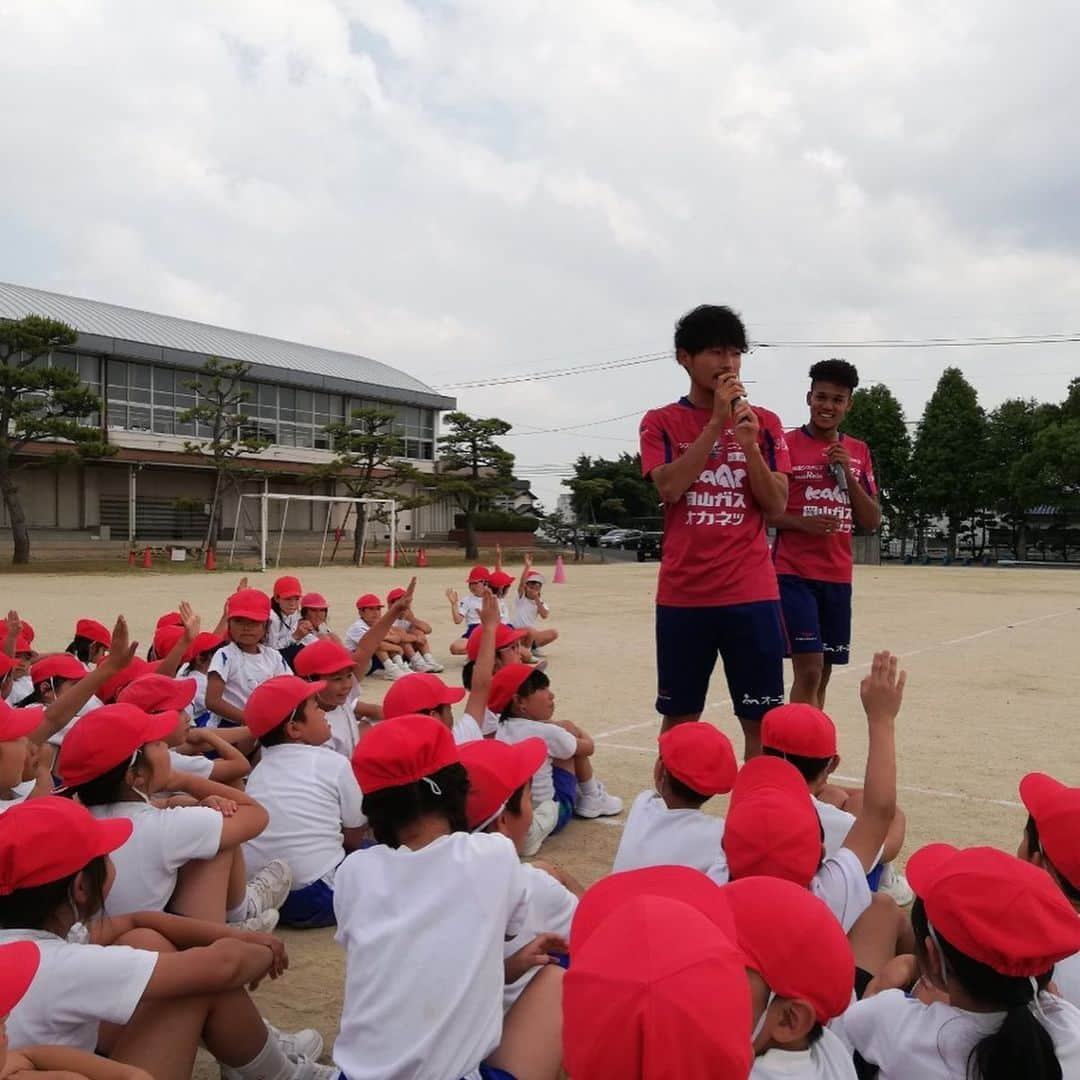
[657,600,787,720]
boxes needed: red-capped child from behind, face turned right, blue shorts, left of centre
[244,673,367,928]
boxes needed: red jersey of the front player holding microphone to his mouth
[639,397,791,607]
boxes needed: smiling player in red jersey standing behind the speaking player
[772,360,881,708]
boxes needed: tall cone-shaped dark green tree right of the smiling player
[912,367,987,556]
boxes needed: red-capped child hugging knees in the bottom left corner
[0,797,337,1080]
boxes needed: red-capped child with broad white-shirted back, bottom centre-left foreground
[334,716,567,1080]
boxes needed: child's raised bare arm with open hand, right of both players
[843,652,907,873]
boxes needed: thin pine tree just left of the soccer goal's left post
[179,356,272,551]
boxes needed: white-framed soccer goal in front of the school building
[229,491,397,570]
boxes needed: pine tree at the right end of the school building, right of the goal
[429,413,514,558]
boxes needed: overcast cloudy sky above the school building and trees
[0,0,1080,505]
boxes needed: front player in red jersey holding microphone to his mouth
[640,305,788,758]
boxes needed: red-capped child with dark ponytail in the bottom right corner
[836,843,1080,1080]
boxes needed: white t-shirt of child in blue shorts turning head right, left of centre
[244,743,367,889]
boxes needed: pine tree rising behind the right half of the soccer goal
[313,407,429,566]
